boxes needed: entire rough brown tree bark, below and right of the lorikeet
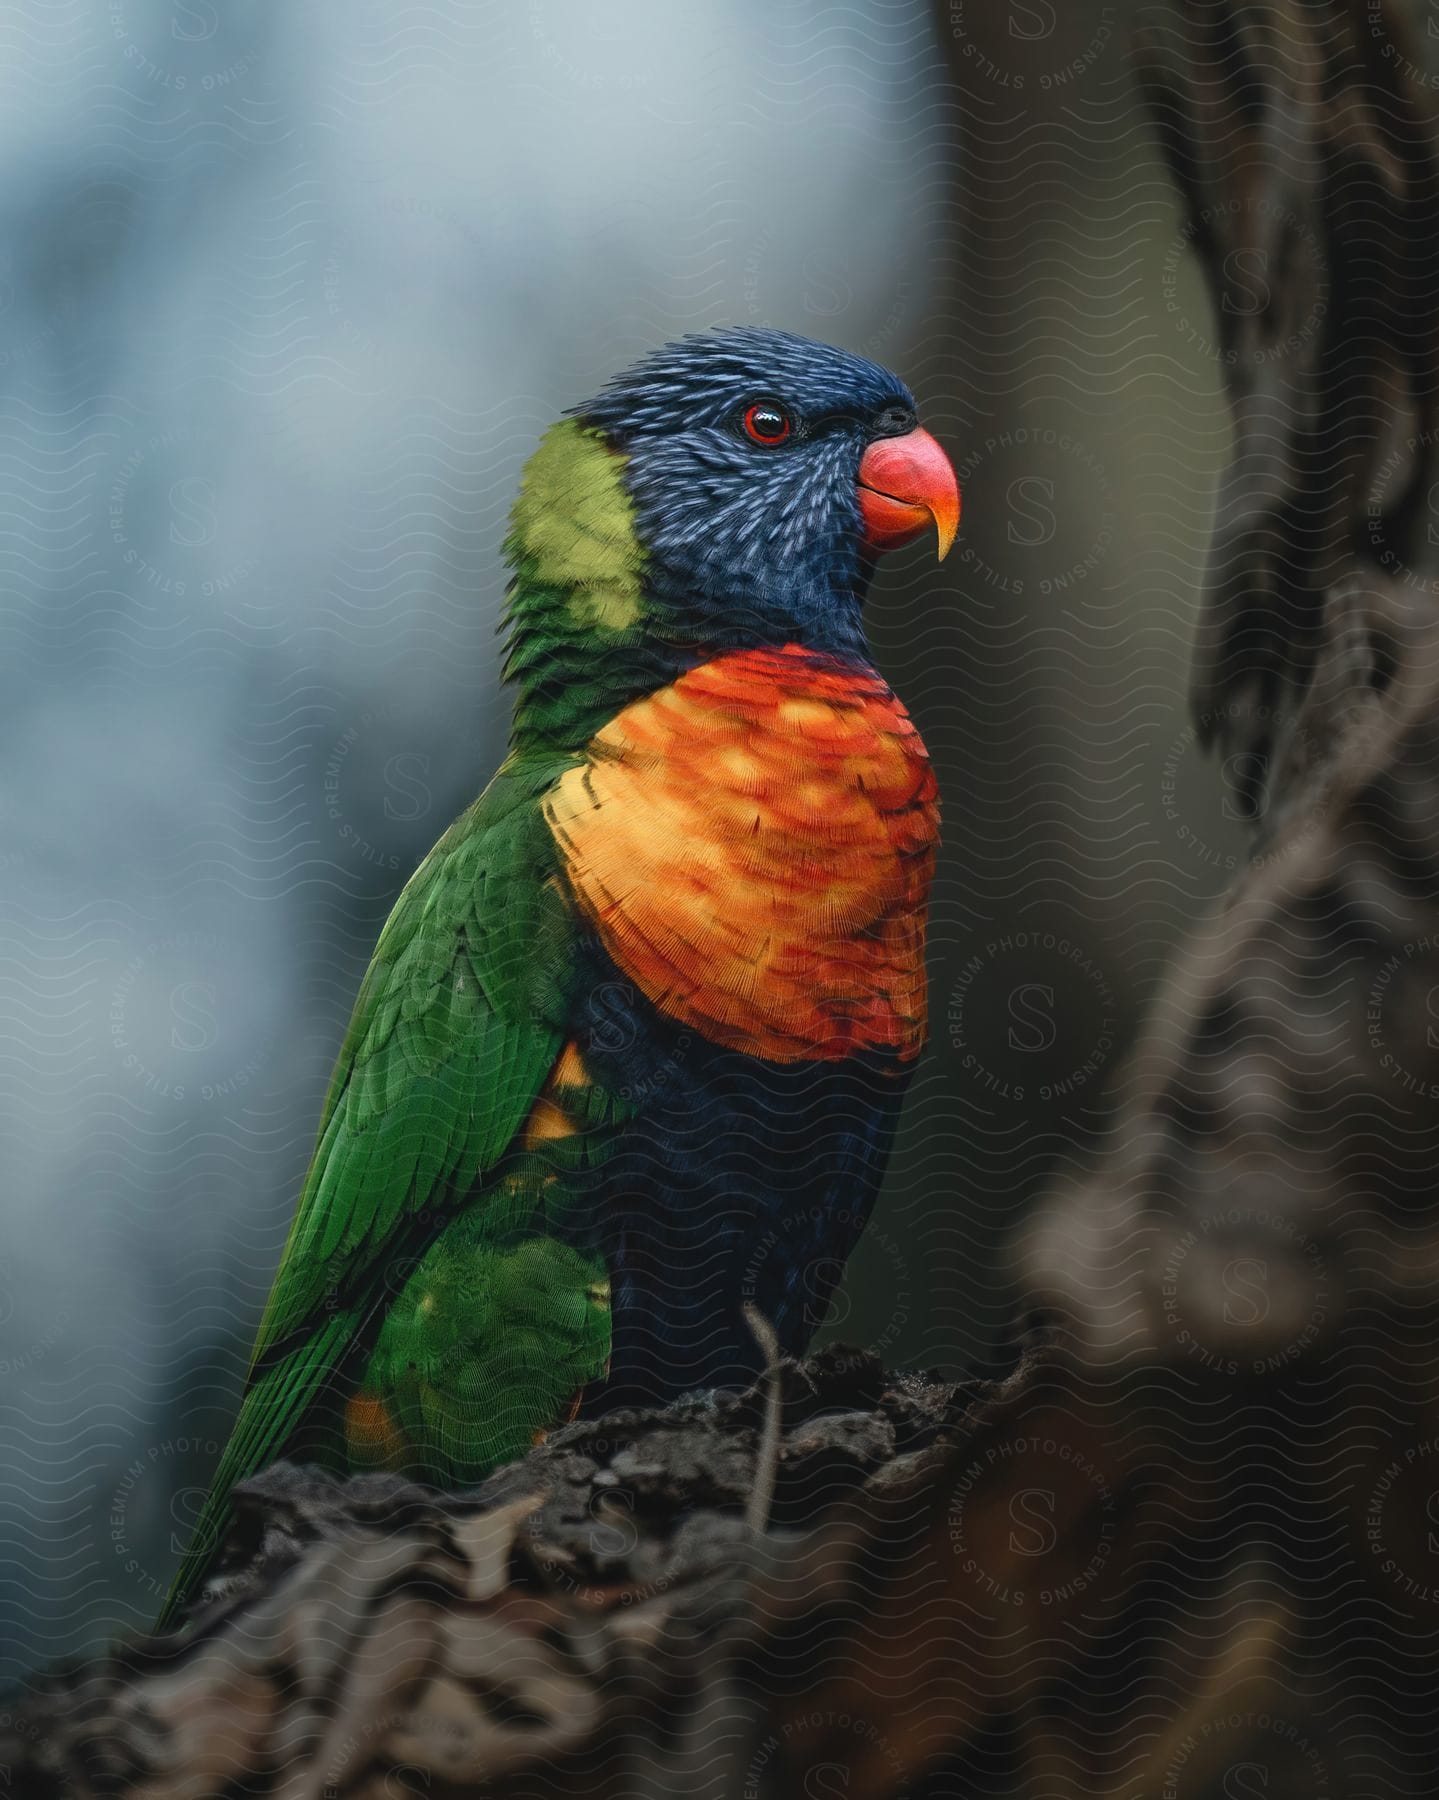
[0,0,1439,1800]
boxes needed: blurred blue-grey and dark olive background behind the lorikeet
[0,0,1239,1674]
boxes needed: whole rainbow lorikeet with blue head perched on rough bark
[167,329,960,1611]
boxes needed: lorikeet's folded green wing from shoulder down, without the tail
[252,760,569,1368]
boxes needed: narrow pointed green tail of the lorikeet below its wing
[155,1316,355,1631]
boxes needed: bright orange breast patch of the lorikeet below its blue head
[548,646,938,1062]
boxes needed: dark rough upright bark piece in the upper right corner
[1135,0,1439,805]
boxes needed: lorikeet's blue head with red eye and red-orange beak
[575,328,960,650]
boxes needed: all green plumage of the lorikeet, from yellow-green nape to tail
[162,421,648,1622]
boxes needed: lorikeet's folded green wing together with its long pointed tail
[162,758,573,1622]
